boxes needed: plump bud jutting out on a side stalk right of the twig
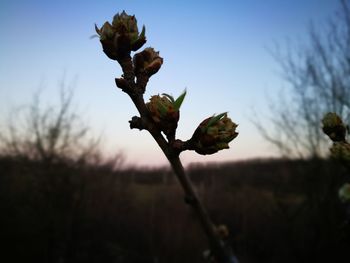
[190,113,238,155]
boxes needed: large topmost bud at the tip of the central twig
[95,11,146,60]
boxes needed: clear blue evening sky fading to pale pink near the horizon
[0,0,338,166]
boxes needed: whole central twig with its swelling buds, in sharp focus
[95,12,238,263]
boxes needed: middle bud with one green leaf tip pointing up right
[146,91,186,136]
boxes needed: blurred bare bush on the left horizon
[0,80,105,166]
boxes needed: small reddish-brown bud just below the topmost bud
[133,47,163,77]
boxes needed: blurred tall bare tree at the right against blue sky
[254,0,350,158]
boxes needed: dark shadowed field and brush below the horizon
[0,157,350,263]
